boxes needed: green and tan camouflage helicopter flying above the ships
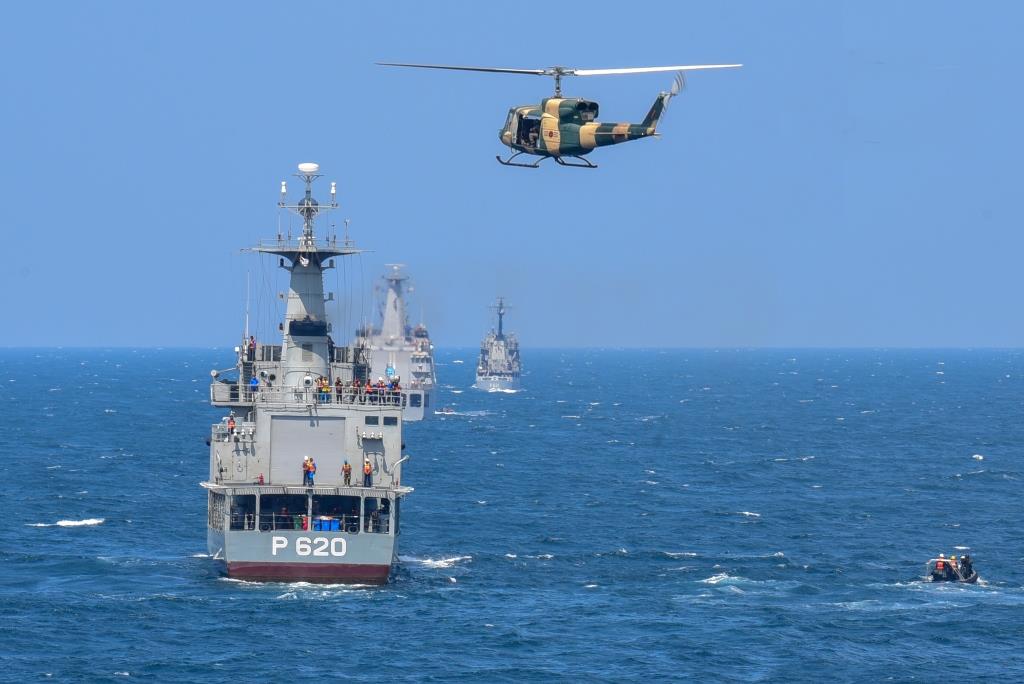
[377,61,742,169]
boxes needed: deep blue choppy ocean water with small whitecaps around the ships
[0,349,1024,682]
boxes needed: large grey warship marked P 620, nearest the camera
[202,163,413,584]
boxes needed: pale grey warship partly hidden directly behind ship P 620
[355,264,437,421]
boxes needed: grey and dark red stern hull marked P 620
[207,528,395,585]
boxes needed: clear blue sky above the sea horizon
[0,2,1024,346]
